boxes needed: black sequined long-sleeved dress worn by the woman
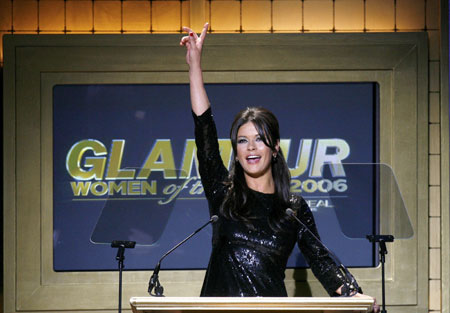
[193,109,344,297]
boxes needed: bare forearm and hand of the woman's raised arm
[180,23,210,116]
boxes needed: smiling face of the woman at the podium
[236,122,274,178]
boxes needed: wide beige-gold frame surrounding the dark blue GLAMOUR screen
[4,34,429,313]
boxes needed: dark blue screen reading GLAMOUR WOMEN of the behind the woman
[53,83,378,271]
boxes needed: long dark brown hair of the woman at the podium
[220,107,290,228]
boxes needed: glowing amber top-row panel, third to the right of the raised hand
[272,0,303,31]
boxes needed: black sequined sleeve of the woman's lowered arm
[298,198,346,296]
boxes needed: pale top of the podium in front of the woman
[130,297,374,313]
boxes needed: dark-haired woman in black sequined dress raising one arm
[180,24,378,311]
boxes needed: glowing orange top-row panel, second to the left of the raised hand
[122,1,151,32]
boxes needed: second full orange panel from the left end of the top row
[39,0,64,32]
